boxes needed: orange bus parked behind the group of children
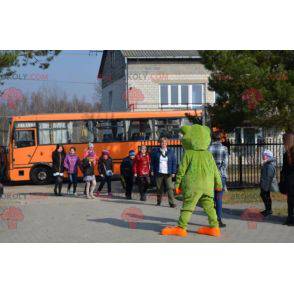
[0,110,200,184]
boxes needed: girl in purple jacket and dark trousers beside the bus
[64,147,80,196]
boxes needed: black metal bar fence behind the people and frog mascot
[142,140,284,188]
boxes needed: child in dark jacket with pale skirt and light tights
[82,156,96,199]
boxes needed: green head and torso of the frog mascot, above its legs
[175,125,222,198]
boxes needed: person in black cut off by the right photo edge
[280,133,294,226]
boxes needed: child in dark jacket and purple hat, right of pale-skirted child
[97,150,113,197]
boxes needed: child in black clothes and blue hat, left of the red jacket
[120,150,136,199]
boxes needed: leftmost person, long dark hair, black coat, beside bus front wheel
[52,144,66,196]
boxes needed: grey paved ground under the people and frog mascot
[0,182,294,242]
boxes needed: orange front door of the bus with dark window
[12,128,37,166]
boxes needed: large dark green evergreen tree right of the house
[200,50,294,132]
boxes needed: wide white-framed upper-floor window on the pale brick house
[160,84,205,107]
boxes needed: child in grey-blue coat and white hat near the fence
[260,150,279,216]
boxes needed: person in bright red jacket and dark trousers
[133,146,151,201]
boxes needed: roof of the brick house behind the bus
[97,50,201,78]
